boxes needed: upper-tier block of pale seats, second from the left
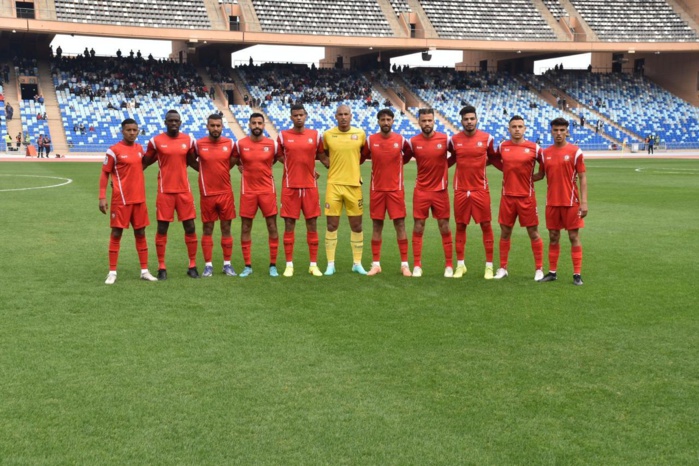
[252,0,393,37]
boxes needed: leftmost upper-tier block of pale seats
[55,0,211,29]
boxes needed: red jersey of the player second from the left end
[146,133,194,193]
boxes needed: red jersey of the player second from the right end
[498,141,543,197]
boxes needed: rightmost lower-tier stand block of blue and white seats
[547,72,699,149]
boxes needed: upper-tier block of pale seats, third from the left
[420,0,556,41]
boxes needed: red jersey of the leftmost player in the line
[102,141,146,205]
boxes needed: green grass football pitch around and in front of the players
[0,159,699,465]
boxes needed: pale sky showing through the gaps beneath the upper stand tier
[52,35,590,74]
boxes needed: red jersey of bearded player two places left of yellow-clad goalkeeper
[236,136,277,194]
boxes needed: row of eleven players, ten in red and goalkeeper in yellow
[99,105,588,285]
